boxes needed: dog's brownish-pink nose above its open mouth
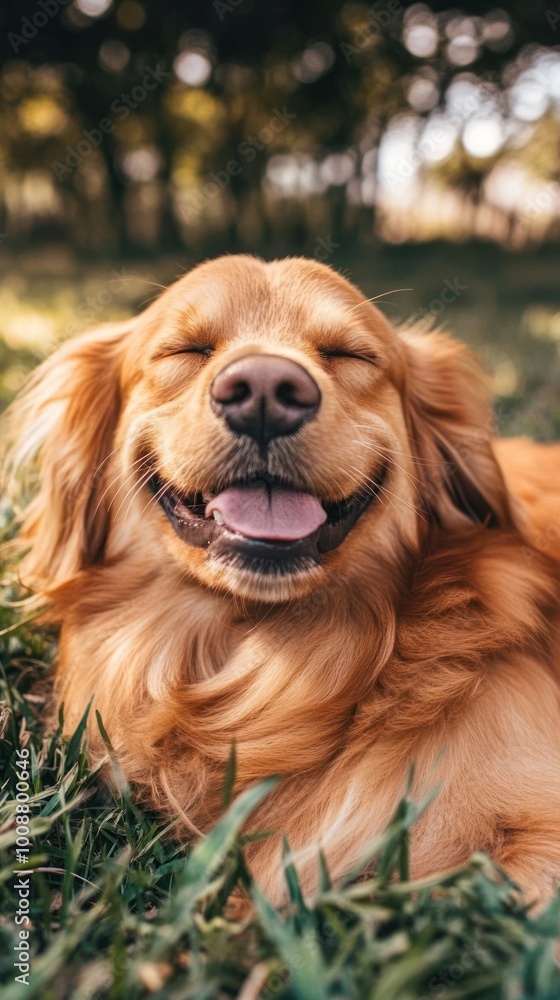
[210,354,321,445]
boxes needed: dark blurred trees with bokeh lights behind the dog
[0,0,560,254]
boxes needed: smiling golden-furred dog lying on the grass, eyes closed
[6,255,560,900]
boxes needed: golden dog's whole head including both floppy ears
[10,257,508,602]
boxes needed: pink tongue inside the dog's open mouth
[206,483,327,542]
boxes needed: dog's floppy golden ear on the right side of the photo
[403,332,514,528]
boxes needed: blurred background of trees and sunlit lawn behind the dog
[0,0,560,439]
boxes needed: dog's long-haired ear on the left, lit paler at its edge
[8,324,130,590]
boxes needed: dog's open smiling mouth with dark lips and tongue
[150,465,387,573]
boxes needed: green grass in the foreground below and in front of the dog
[0,593,560,1000]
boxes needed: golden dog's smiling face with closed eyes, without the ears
[121,258,416,601]
